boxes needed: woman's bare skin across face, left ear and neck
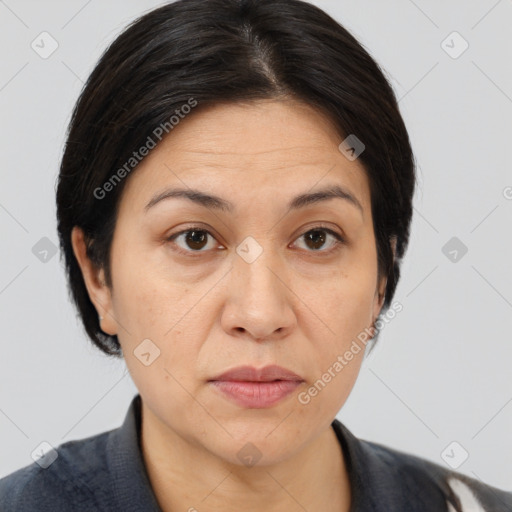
[72,100,392,512]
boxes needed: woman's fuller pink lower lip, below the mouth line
[210,380,302,409]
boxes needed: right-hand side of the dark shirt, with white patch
[332,419,512,512]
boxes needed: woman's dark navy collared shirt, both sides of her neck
[0,395,512,512]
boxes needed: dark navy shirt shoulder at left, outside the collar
[0,432,114,512]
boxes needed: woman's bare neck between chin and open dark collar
[141,402,351,512]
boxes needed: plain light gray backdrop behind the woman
[0,0,512,490]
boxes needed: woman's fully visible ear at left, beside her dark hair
[71,226,117,335]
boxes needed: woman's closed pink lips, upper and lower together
[209,365,304,409]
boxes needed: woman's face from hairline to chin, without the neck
[78,101,385,464]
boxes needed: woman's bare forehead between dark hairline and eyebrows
[121,100,369,211]
